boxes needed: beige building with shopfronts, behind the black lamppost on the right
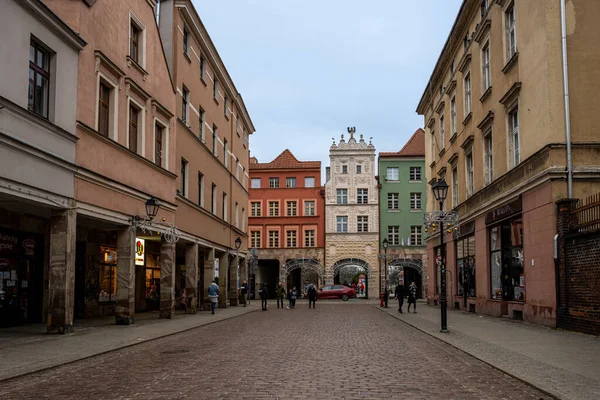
[417,0,600,326]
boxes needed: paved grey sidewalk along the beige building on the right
[377,301,600,400]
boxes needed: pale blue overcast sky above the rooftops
[193,0,462,175]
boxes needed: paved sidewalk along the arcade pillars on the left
[0,300,260,381]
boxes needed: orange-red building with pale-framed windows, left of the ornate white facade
[248,149,325,295]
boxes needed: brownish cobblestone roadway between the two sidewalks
[0,303,549,400]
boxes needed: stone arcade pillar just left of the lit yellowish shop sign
[115,226,136,325]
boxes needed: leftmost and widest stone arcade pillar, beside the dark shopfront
[47,210,77,333]
